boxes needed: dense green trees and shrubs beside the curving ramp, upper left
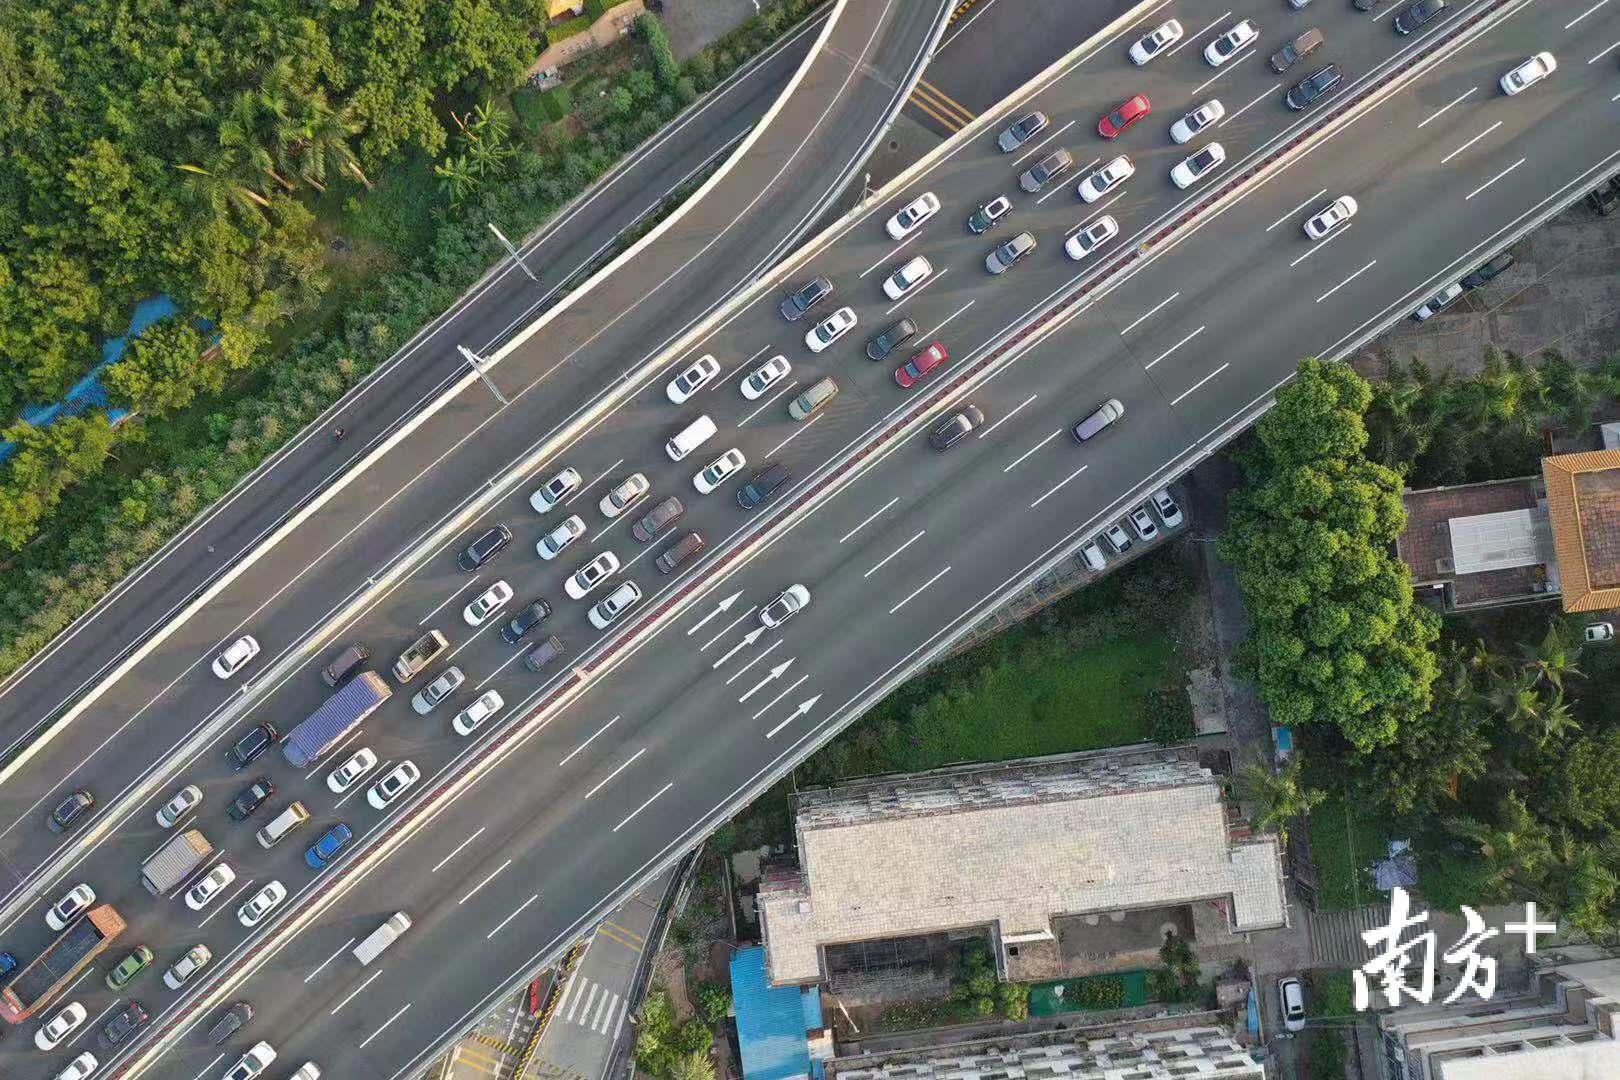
[0,0,813,689]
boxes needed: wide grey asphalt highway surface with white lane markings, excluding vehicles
[3,0,1620,1077]
